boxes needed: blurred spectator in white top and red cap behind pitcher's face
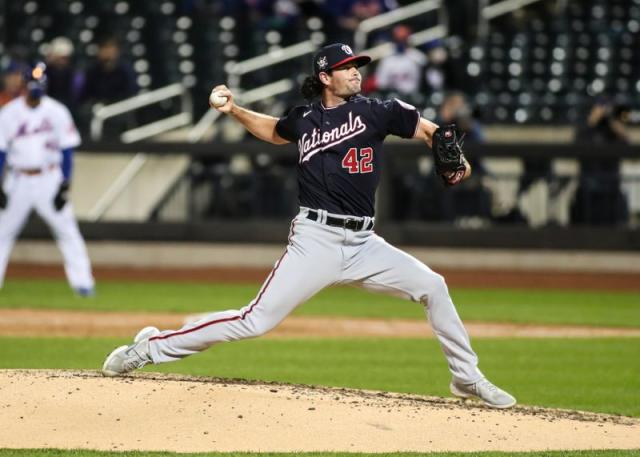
[375,25,427,98]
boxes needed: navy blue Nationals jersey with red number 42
[276,95,420,217]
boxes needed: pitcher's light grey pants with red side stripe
[149,208,483,383]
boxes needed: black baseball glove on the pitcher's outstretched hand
[431,124,466,186]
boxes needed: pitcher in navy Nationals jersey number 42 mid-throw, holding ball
[102,43,516,408]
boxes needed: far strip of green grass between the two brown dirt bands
[0,279,640,327]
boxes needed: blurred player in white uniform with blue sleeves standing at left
[0,64,95,296]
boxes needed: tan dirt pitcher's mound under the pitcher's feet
[0,370,640,452]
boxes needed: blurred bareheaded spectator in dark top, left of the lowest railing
[80,38,138,103]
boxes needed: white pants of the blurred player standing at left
[0,167,94,289]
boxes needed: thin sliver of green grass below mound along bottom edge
[0,449,638,457]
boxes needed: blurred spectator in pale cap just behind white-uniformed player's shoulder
[46,37,82,113]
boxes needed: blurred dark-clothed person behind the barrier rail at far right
[571,99,631,225]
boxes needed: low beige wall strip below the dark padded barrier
[11,241,640,273]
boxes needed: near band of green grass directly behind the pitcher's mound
[0,338,640,416]
